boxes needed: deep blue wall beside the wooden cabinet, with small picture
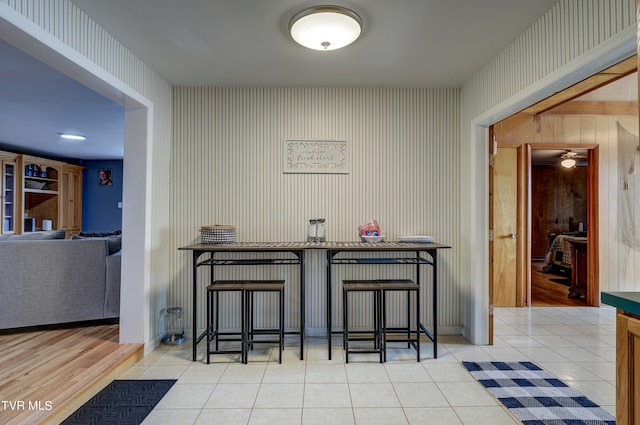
[82,160,122,232]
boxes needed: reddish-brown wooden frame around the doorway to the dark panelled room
[519,143,600,307]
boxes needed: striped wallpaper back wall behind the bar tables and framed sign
[168,87,460,331]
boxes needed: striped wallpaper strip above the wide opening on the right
[462,0,636,117]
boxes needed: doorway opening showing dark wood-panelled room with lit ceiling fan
[527,144,599,307]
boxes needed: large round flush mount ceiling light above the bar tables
[289,6,362,50]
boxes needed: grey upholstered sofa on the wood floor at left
[0,230,122,329]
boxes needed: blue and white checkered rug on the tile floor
[462,362,616,425]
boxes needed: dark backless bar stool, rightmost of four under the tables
[377,279,420,362]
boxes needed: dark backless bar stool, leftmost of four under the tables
[207,280,246,364]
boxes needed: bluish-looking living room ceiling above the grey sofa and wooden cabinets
[0,39,124,159]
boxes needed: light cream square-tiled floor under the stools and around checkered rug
[120,307,615,425]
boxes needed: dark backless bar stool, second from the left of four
[242,280,284,364]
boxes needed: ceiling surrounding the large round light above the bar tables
[72,0,558,87]
